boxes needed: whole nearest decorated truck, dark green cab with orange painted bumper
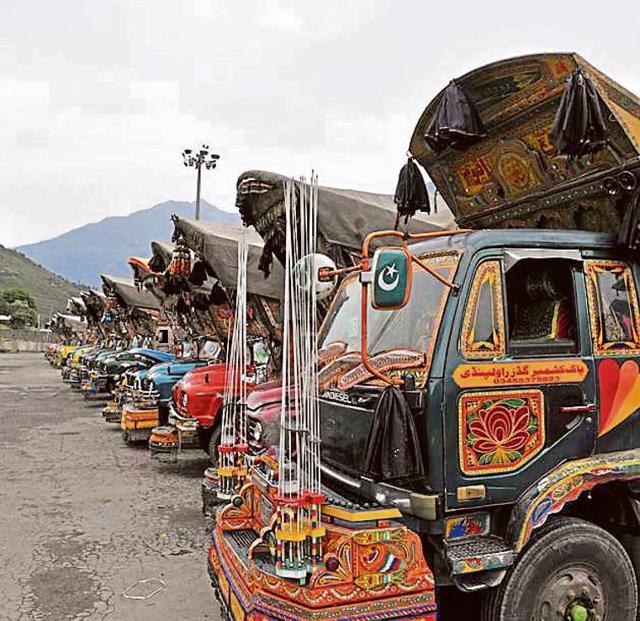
[209,54,640,621]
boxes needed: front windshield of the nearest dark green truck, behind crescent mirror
[318,253,458,362]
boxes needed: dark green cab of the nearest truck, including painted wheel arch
[222,229,640,621]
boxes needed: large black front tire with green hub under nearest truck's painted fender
[482,517,638,621]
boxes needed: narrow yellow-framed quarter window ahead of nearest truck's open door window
[460,261,505,360]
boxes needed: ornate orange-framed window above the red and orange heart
[585,260,640,355]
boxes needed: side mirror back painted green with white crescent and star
[371,247,411,310]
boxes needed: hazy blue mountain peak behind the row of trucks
[18,201,240,287]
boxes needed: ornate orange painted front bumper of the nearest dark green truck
[208,475,437,621]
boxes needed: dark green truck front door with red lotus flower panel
[443,249,597,508]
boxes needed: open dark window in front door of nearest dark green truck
[505,259,578,356]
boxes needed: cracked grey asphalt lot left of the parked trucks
[0,354,220,621]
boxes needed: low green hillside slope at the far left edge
[0,246,81,319]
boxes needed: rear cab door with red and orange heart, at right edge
[585,257,640,453]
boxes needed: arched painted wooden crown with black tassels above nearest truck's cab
[409,53,640,233]
